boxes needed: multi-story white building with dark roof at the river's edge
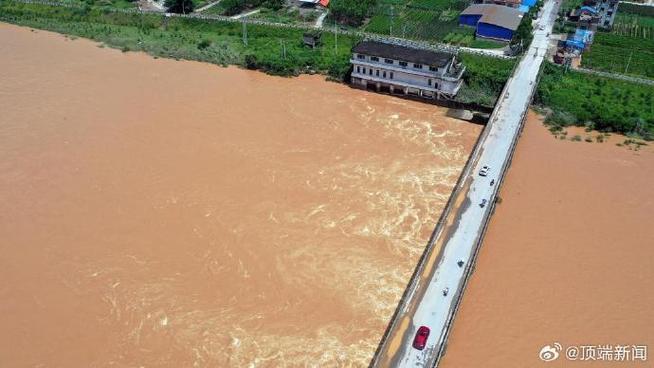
[351,41,465,99]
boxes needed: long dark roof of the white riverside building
[352,41,454,67]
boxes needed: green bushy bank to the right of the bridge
[536,63,654,140]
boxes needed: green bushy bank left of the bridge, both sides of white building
[0,1,515,108]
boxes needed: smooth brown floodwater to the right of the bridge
[441,114,654,368]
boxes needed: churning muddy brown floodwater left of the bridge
[0,24,480,367]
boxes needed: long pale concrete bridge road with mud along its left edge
[370,0,559,368]
